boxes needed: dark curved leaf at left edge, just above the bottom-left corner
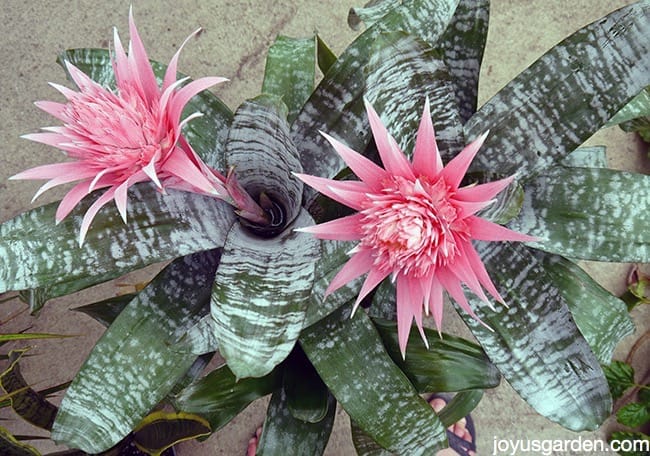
[0,349,57,431]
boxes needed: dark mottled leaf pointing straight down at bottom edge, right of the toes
[256,389,336,456]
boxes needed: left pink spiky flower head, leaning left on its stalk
[12,8,228,243]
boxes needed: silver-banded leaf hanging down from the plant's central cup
[211,210,320,378]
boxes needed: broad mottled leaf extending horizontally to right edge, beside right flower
[511,166,650,262]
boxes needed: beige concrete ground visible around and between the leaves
[0,0,650,456]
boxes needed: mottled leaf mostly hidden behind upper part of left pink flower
[58,49,232,171]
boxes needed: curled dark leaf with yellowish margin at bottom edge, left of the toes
[133,411,211,455]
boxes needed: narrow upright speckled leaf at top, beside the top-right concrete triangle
[434,0,490,123]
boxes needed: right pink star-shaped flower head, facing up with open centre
[298,99,534,356]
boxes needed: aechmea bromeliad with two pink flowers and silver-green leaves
[0,0,650,455]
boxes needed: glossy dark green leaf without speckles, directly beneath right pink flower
[374,320,501,393]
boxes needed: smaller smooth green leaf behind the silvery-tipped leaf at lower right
[533,251,634,364]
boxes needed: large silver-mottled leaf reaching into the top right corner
[466,2,650,178]
